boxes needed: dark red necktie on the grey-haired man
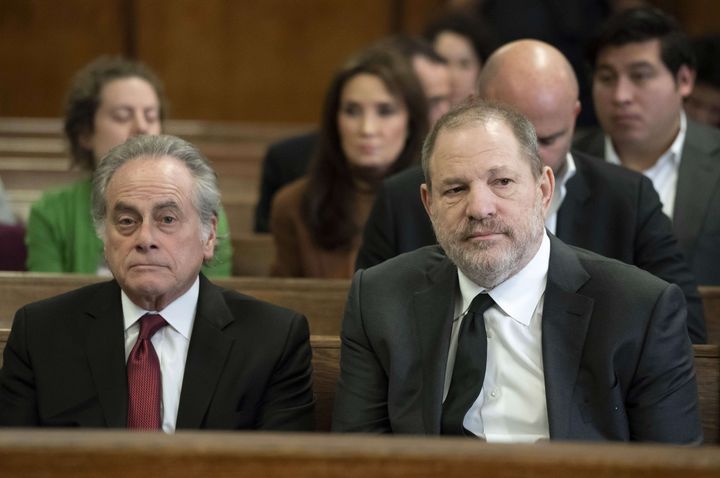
[127,314,167,430]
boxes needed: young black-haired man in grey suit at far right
[575,7,720,285]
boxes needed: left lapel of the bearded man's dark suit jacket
[413,252,457,434]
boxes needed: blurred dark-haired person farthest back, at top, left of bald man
[425,12,495,105]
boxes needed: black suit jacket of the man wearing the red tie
[0,275,314,430]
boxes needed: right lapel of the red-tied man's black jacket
[176,274,234,429]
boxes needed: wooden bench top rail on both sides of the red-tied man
[0,272,350,335]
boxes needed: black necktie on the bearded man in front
[441,293,493,435]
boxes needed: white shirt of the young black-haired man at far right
[605,112,687,219]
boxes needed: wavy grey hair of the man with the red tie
[92,135,220,243]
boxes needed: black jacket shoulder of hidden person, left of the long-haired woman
[255,132,318,232]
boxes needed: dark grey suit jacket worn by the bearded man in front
[333,241,702,443]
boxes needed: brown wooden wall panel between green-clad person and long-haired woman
[136,0,392,121]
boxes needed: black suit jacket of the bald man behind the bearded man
[356,157,707,343]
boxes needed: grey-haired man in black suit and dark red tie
[0,136,314,432]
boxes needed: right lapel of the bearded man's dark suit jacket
[542,236,593,439]
